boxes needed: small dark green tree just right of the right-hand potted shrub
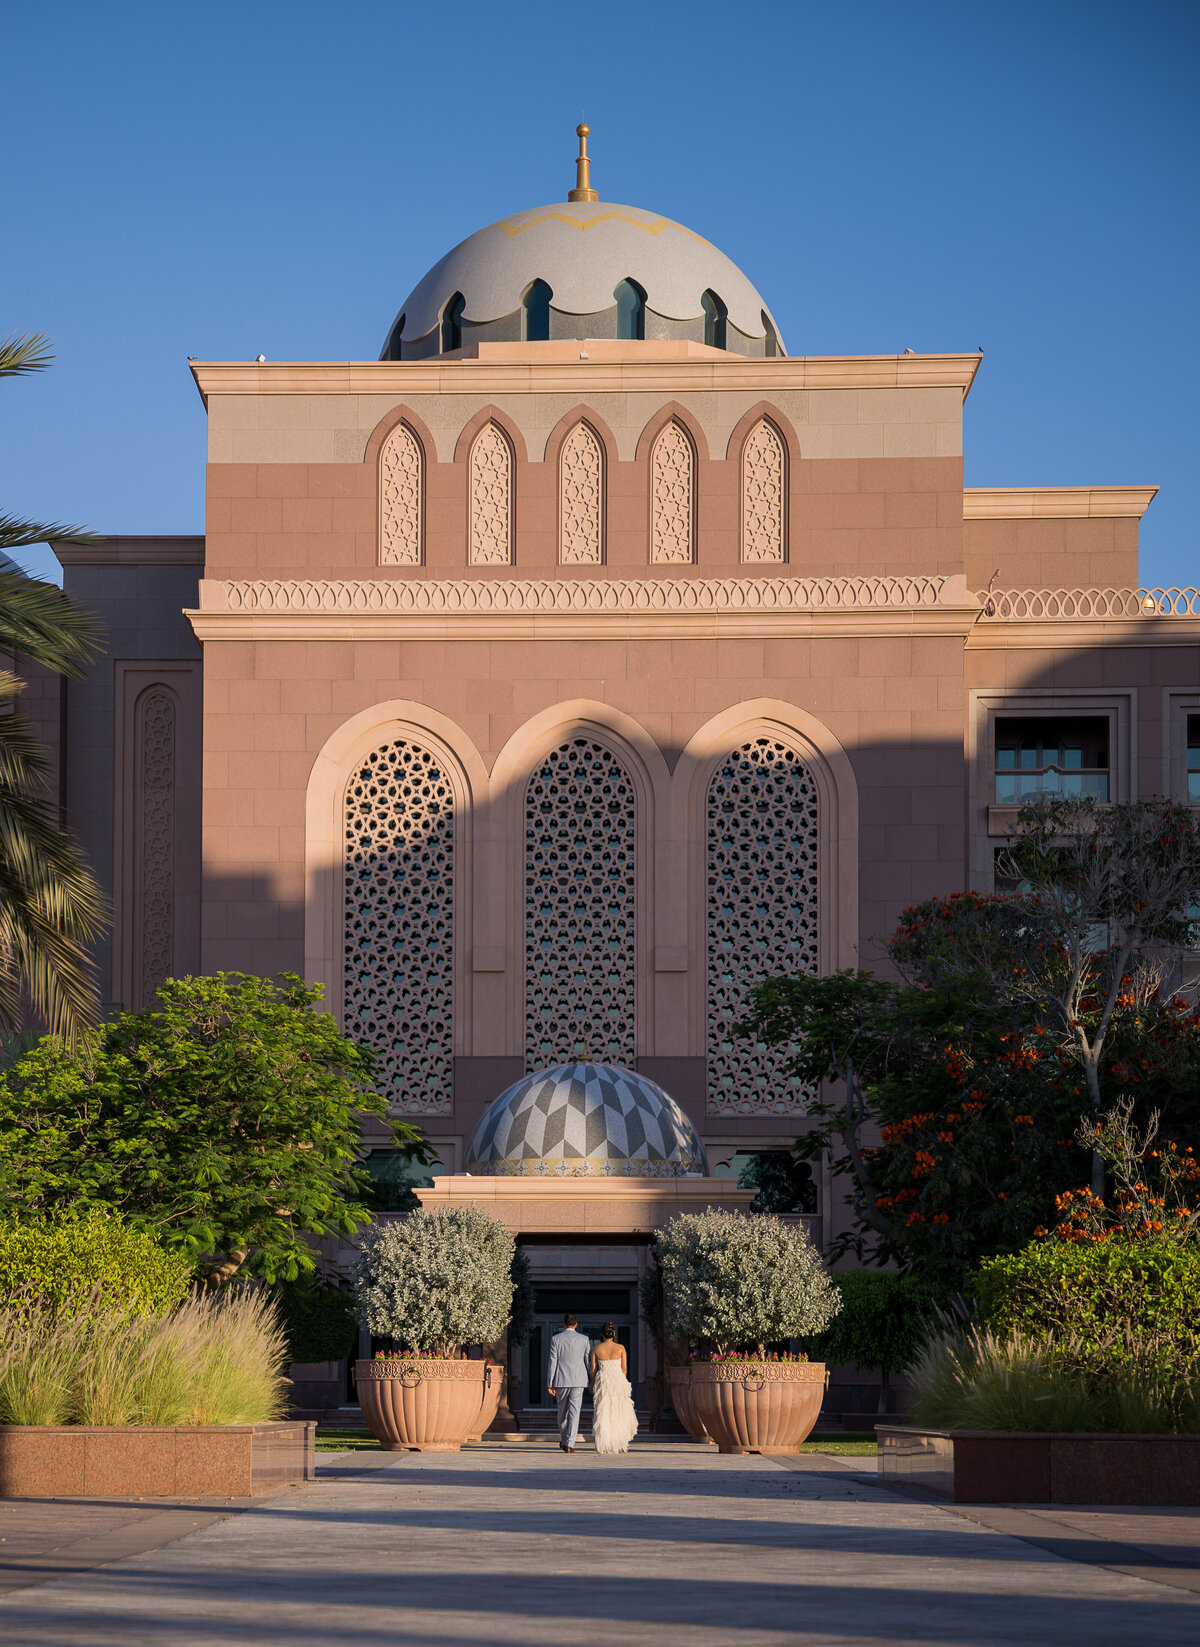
[807,1270,938,1413]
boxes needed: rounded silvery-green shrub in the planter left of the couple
[354,1207,515,1355]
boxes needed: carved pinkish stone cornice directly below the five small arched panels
[186,578,979,641]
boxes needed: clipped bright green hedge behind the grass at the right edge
[973,1237,1200,1355]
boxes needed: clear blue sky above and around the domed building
[0,0,1200,583]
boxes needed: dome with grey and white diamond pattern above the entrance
[464,1064,708,1178]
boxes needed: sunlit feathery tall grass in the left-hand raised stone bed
[0,1290,288,1425]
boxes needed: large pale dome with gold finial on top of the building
[380,125,787,361]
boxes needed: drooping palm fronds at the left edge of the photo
[0,333,107,1039]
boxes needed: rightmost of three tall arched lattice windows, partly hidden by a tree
[706,738,820,1115]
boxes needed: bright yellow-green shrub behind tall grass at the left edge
[0,1207,193,1314]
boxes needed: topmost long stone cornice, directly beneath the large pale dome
[189,354,981,405]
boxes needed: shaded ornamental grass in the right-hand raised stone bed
[909,1327,1200,1435]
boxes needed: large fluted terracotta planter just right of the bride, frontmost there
[691,1360,825,1453]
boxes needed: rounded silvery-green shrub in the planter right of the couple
[653,1207,841,1354]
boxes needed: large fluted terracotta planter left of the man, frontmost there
[354,1355,487,1453]
